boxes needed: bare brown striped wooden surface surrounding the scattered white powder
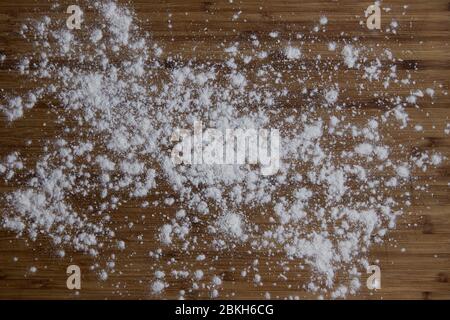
[0,0,450,299]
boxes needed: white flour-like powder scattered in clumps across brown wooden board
[0,1,443,298]
